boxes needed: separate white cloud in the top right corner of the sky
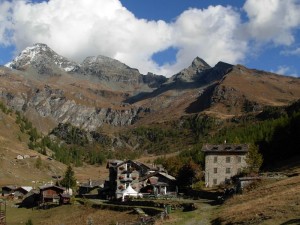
[244,0,300,45]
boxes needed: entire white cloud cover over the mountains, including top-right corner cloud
[0,0,300,76]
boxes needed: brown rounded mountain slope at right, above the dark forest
[188,65,300,116]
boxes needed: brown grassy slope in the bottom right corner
[217,163,300,224]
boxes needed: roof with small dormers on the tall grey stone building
[202,144,249,153]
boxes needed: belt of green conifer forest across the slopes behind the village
[0,100,300,185]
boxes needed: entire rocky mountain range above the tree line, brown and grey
[0,44,300,131]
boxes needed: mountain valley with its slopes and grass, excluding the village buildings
[0,44,300,225]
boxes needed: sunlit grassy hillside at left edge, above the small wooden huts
[0,107,66,186]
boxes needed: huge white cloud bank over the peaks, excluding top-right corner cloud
[0,0,246,75]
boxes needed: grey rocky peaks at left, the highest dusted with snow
[5,43,166,90]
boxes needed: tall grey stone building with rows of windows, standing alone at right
[202,144,249,187]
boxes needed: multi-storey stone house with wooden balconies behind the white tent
[104,160,176,198]
